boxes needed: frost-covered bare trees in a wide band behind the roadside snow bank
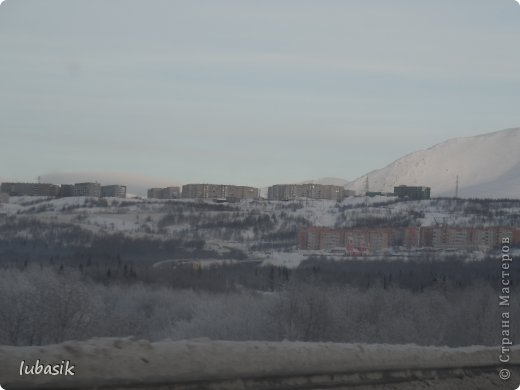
[0,266,520,346]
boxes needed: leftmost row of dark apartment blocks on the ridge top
[0,183,126,198]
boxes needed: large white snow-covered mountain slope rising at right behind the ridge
[346,128,520,198]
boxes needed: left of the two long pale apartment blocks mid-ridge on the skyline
[182,184,259,199]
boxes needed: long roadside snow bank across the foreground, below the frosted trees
[0,338,520,389]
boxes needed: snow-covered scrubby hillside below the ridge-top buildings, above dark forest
[0,196,520,268]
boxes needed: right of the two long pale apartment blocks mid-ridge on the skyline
[267,184,354,200]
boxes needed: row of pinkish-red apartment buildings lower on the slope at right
[299,226,520,254]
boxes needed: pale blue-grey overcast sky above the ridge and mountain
[0,0,520,190]
